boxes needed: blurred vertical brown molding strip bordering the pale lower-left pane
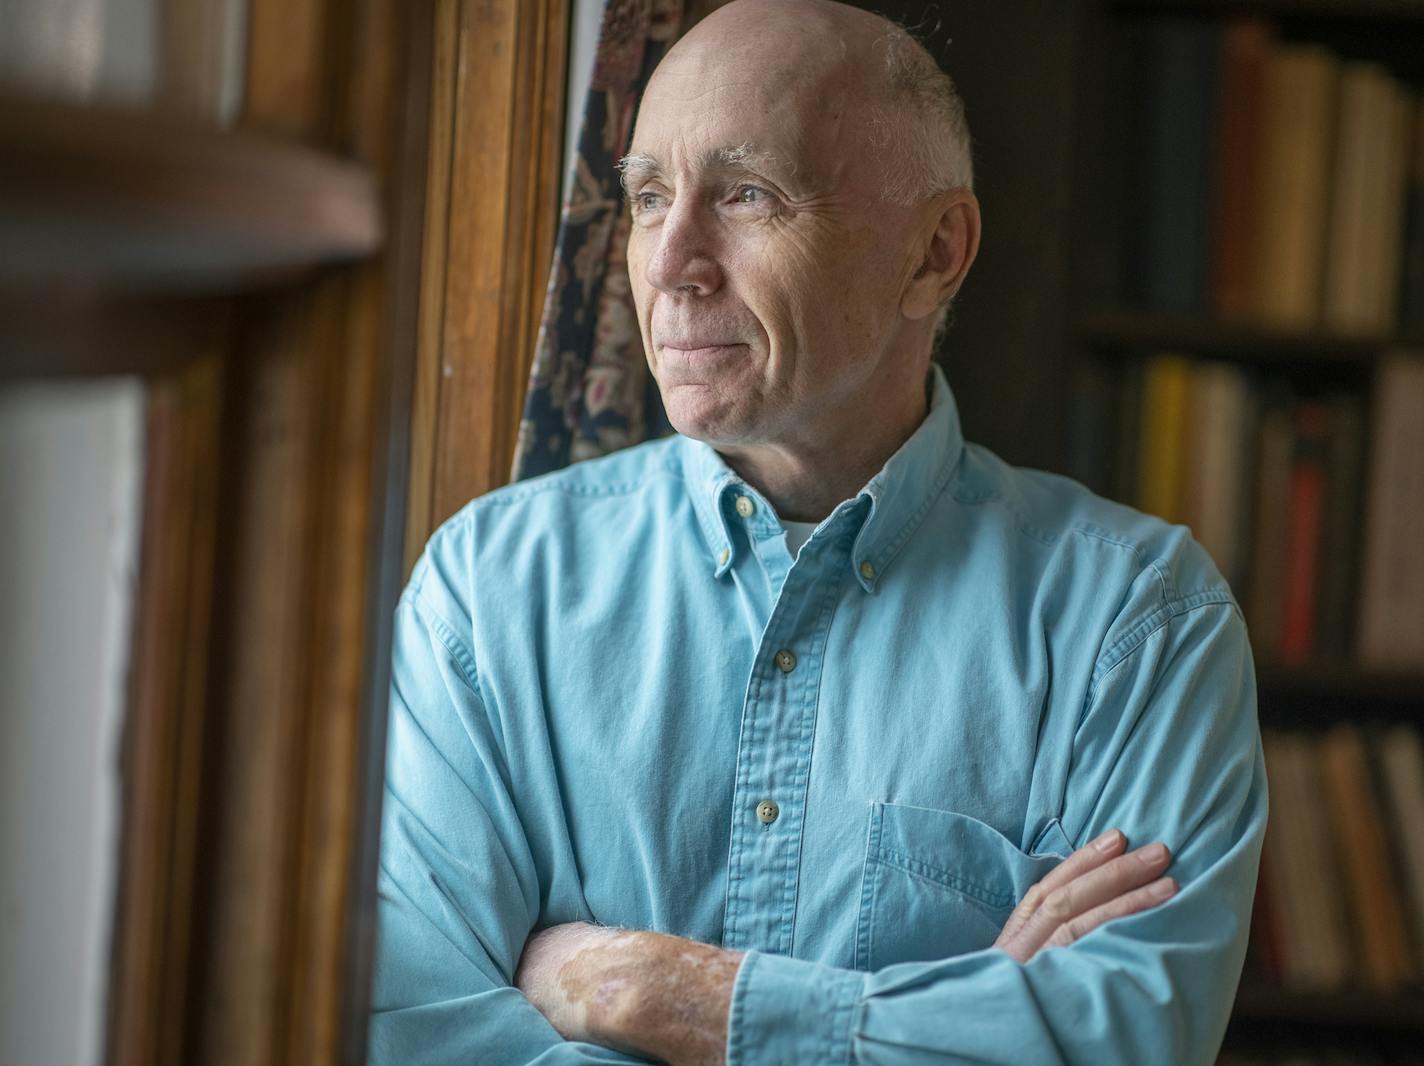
[108,346,222,1066]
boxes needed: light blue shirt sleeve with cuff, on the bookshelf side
[728,596,1266,1066]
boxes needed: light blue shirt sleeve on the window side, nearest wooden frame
[367,558,655,1066]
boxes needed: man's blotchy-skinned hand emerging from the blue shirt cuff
[514,922,742,1066]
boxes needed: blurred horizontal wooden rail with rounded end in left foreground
[0,91,382,295]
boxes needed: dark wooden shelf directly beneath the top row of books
[1077,310,1424,369]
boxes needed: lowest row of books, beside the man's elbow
[1250,723,1424,991]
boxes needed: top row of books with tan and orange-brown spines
[1128,16,1424,336]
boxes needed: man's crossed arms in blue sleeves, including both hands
[370,560,1265,1066]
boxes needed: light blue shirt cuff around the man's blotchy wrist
[726,951,866,1066]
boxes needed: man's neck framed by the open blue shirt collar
[718,375,930,522]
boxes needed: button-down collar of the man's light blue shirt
[681,364,964,592]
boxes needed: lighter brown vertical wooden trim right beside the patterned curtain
[406,0,570,569]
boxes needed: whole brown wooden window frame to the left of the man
[0,0,570,1066]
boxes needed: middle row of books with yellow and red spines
[1068,353,1424,669]
